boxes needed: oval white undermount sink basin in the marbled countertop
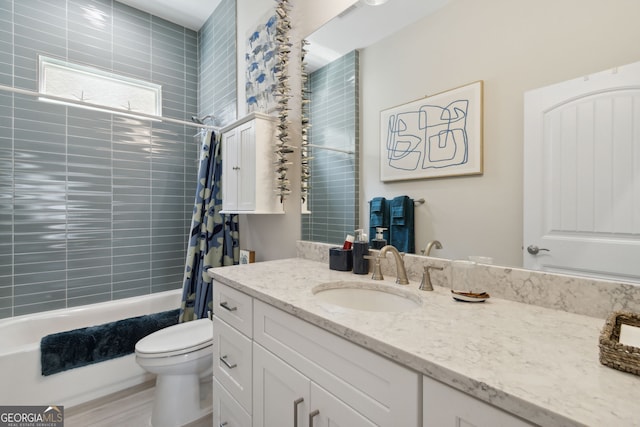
[312,281,422,312]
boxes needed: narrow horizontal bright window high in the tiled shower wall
[38,55,162,118]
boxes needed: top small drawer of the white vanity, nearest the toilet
[213,281,253,338]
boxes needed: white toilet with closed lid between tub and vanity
[136,319,213,427]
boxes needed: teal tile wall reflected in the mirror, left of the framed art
[302,51,360,244]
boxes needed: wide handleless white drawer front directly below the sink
[254,301,421,426]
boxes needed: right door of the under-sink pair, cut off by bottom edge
[308,383,376,427]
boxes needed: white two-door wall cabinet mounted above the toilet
[221,112,283,214]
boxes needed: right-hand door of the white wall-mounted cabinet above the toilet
[236,120,256,211]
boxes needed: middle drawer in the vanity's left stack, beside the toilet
[213,316,252,413]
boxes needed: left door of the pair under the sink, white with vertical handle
[253,343,309,427]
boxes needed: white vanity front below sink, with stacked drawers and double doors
[213,281,421,427]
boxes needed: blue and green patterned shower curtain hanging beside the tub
[179,131,240,322]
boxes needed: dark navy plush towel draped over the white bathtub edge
[40,309,180,375]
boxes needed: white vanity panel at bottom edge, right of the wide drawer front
[422,376,534,427]
